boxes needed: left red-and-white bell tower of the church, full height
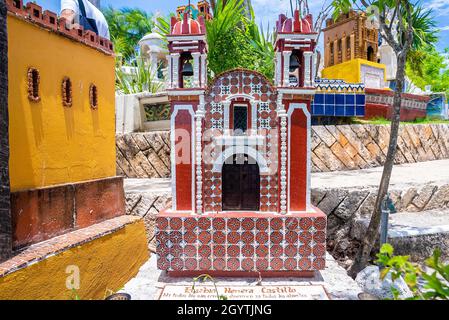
[166,5,207,212]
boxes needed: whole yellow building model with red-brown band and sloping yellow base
[0,0,148,299]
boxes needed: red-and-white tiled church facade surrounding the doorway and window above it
[202,70,278,213]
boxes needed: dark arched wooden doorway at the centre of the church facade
[222,154,260,211]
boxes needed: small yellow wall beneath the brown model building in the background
[321,59,387,83]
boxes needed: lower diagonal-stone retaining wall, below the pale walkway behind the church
[126,180,449,252]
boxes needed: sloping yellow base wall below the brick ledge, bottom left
[0,220,148,300]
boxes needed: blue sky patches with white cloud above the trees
[24,0,449,51]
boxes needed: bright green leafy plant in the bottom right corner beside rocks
[377,244,449,300]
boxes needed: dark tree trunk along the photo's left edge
[0,0,12,262]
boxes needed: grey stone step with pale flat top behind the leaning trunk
[351,209,449,262]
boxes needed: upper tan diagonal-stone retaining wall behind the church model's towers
[116,124,449,178]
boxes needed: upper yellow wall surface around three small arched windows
[8,16,116,191]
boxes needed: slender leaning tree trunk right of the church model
[349,52,407,278]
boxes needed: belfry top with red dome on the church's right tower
[275,10,317,88]
